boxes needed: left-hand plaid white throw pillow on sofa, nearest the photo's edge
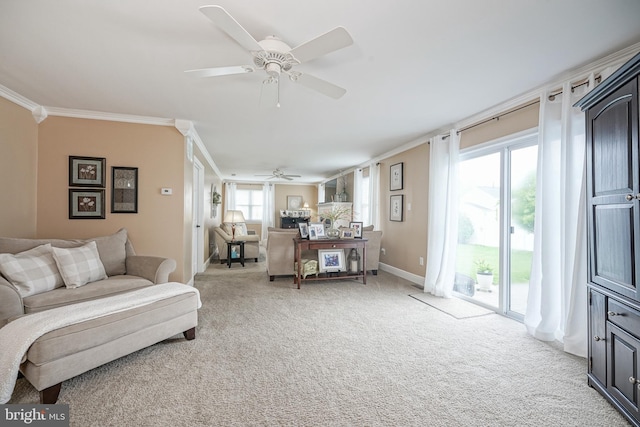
[0,243,63,298]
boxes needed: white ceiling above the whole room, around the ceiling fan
[0,0,640,182]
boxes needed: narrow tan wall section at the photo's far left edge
[0,98,38,238]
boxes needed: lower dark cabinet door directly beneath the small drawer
[607,322,640,417]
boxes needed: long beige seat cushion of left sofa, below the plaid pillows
[23,276,153,313]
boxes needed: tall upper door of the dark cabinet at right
[587,79,640,299]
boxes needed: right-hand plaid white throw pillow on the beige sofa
[51,241,107,288]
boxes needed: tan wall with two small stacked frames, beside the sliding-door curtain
[380,143,429,276]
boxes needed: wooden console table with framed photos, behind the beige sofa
[293,237,367,289]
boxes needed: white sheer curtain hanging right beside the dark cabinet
[524,75,594,357]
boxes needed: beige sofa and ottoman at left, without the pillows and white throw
[0,229,199,403]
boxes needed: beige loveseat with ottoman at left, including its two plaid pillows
[0,229,200,403]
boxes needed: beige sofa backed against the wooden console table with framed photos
[267,226,382,281]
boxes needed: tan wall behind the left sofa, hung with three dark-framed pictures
[37,117,192,282]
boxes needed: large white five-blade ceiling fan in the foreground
[186,6,353,107]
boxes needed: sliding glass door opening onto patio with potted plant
[454,134,537,319]
